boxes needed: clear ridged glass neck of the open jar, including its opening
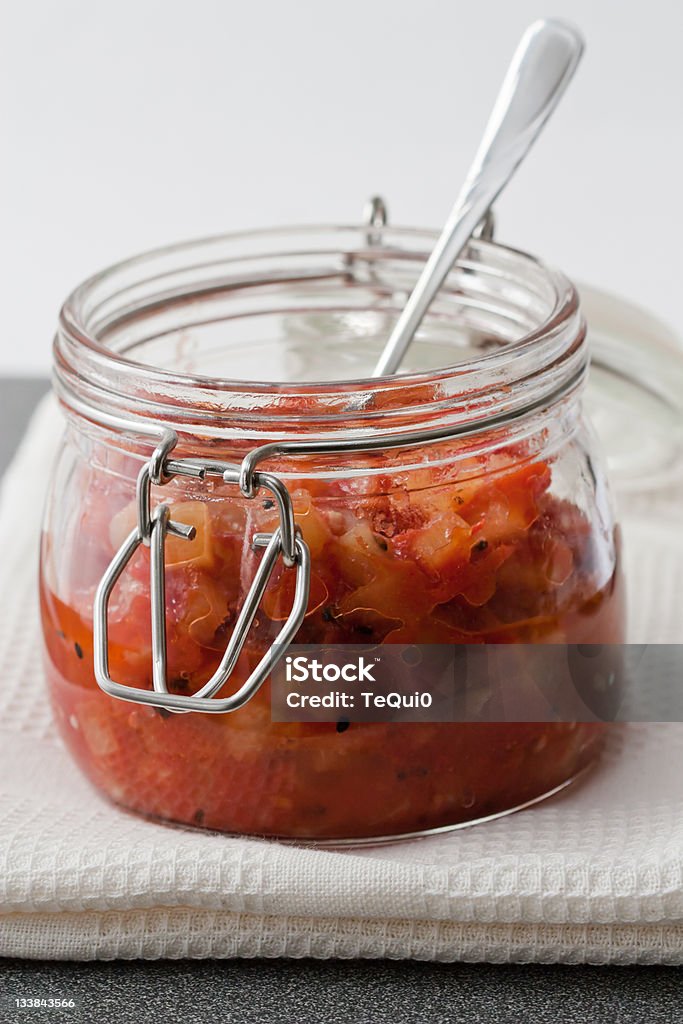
[54,227,588,468]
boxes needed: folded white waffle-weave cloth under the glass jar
[0,401,683,964]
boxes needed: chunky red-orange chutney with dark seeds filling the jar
[41,451,624,840]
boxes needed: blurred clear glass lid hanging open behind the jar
[578,285,683,492]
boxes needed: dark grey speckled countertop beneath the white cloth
[0,380,683,1024]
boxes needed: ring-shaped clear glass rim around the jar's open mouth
[54,224,587,442]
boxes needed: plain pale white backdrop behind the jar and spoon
[0,0,683,373]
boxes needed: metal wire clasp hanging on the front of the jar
[93,430,310,714]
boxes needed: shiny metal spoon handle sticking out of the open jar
[373,18,584,377]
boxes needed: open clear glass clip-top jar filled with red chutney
[41,227,625,842]
